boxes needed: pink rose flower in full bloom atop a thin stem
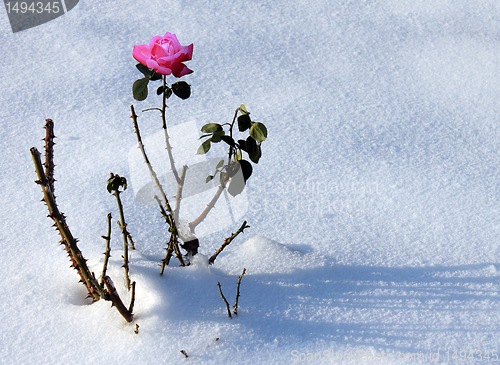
[132,32,193,77]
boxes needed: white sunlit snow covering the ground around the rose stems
[0,0,500,364]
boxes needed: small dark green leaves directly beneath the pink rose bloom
[132,63,191,101]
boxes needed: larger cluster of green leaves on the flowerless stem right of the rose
[197,104,267,196]
